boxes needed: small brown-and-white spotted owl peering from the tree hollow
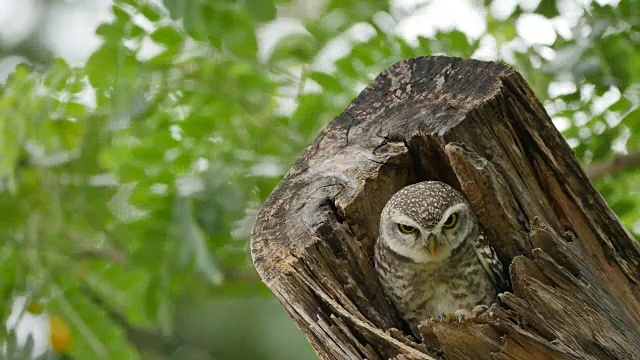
[374,181,505,338]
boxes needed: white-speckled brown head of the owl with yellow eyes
[378,181,477,263]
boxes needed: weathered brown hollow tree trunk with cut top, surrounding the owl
[251,57,640,359]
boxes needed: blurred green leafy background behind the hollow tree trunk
[0,0,640,360]
